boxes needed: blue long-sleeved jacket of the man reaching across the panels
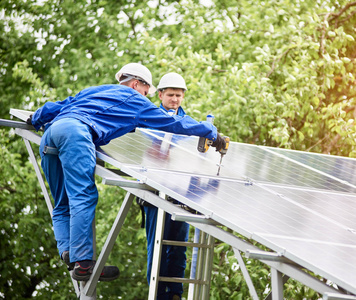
[32,84,217,146]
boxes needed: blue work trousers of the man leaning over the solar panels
[40,118,98,262]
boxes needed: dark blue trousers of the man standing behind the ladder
[144,206,189,300]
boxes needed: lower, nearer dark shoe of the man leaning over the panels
[72,260,120,281]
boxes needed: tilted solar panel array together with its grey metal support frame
[5,110,356,299]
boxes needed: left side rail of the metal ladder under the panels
[148,208,166,300]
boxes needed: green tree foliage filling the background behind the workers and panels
[0,0,356,299]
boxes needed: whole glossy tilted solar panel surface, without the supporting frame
[102,129,356,293]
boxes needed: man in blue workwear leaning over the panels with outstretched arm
[27,63,224,281]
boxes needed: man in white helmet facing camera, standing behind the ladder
[143,73,189,300]
